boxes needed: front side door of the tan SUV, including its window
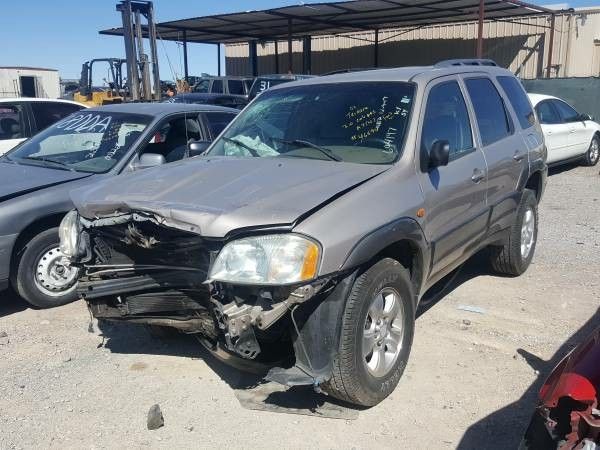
[417,77,487,277]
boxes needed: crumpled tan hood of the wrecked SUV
[71,157,388,237]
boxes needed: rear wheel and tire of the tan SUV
[490,189,538,276]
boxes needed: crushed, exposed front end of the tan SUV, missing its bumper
[68,212,353,385]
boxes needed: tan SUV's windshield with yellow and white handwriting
[209,82,414,164]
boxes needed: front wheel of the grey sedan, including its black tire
[12,228,77,308]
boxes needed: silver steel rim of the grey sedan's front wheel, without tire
[35,246,77,297]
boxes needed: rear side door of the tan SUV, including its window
[463,75,535,233]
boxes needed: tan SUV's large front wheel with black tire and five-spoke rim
[323,258,415,406]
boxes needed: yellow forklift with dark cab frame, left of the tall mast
[73,58,127,106]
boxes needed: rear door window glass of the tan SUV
[466,78,511,147]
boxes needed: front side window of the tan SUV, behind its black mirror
[421,81,473,160]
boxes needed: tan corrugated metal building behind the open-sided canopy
[225,8,600,79]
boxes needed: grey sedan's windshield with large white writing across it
[6,111,152,173]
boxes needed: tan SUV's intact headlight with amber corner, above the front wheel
[209,234,320,285]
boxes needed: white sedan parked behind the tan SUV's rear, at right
[529,94,600,166]
